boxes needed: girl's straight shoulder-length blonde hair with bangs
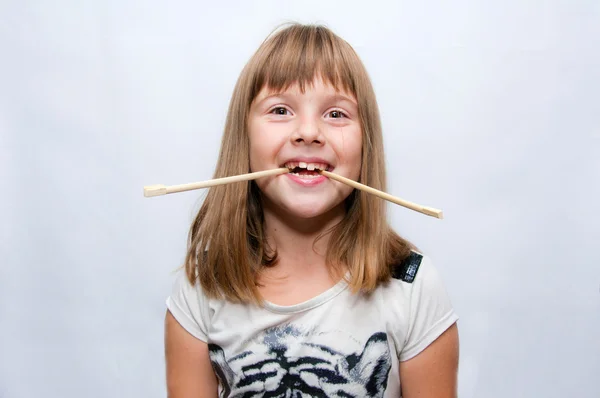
[185,24,412,304]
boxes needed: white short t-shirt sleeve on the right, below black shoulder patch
[399,256,458,361]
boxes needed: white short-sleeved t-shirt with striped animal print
[167,252,458,398]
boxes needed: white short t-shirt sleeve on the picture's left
[167,270,208,342]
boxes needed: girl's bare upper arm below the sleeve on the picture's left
[165,311,217,398]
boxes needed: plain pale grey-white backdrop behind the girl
[0,0,600,398]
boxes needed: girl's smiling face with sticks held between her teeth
[248,78,362,218]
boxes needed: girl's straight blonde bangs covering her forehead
[250,25,360,101]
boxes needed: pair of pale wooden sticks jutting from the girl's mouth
[144,167,443,219]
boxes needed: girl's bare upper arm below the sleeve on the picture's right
[400,323,458,398]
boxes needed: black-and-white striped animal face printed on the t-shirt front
[209,325,391,398]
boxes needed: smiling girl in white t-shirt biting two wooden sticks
[165,24,458,398]
